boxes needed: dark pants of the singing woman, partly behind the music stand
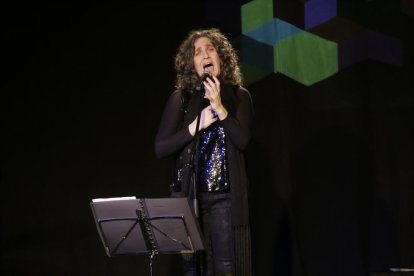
[183,193,234,276]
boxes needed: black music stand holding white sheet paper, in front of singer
[90,197,204,275]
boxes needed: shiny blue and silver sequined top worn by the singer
[198,122,230,192]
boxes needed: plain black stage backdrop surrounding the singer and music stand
[1,0,414,276]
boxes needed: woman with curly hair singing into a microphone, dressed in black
[154,28,253,276]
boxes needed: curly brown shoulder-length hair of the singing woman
[175,28,243,91]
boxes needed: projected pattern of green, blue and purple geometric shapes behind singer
[206,0,403,86]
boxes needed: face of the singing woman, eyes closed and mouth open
[194,37,220,77]
